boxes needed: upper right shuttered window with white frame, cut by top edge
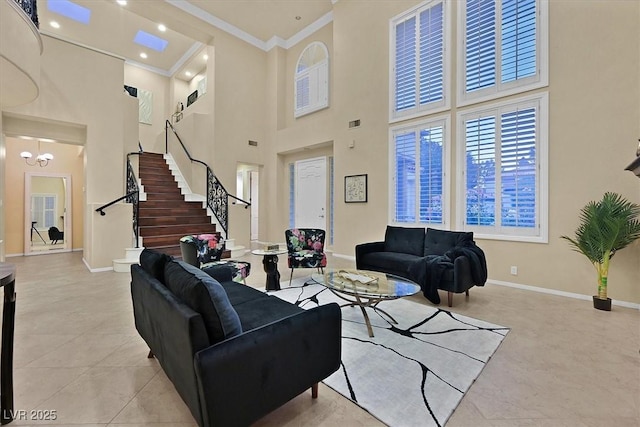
[458,0,548,105]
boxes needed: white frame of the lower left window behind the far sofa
[388,114,452,229]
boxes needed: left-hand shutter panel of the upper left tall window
[395,16,416,111]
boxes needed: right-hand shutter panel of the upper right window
[501,0,537,83]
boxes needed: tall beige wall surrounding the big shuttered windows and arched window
[269,1,640,303]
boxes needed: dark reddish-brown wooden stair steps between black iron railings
[138,153,220,257]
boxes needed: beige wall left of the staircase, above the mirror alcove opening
[5,36,132,269]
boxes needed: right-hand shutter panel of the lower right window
[500,108,537,227]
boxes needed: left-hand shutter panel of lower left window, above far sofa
[394,131,416,222]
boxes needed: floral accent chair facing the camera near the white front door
[284,228,327,283]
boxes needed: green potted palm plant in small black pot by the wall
[561,192,640,311]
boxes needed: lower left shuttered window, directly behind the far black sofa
[392,119,446,224]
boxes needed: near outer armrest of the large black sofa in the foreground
[194,303,342,426]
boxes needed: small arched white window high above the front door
[294,42,329,117]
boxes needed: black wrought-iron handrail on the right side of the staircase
[164,120,251,239]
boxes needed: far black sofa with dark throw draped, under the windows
[356,226,487,307]
